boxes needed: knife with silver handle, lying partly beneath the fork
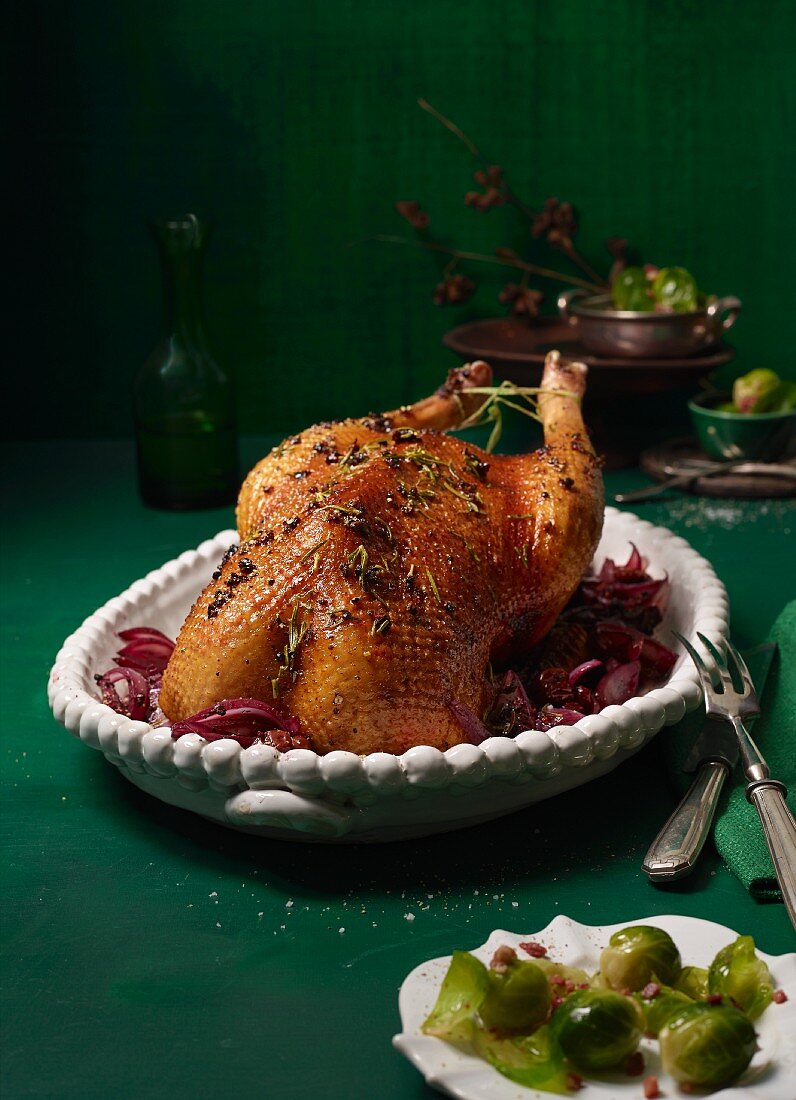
[641,642,776,884]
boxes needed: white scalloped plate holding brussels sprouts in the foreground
[393,914,796,1100]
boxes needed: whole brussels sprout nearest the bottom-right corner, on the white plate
[659,1001,758,1089]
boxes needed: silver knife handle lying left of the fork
[641,760,729,883]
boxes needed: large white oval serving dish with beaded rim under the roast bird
[48,508,728,842]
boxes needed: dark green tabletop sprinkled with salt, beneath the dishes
[2,440,796,1100]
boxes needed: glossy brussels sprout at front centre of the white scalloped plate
[550,989,644,1070]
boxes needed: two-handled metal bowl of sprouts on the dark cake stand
[559,288,741,359]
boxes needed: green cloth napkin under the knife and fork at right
[661,600,796,900]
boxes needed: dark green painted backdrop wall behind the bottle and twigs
[4,0,796,437]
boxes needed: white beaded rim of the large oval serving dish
[47,508,729,807]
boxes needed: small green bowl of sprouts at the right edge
[688,394,796,462]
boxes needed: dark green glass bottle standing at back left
[133,215,239,509]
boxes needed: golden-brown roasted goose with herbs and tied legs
[161,352,602,754]
